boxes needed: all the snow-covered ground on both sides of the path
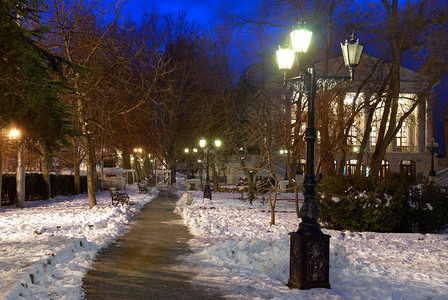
[0,187,448,299]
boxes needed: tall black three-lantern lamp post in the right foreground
[277,22,363,289]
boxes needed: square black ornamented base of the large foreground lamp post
[287,232,331,290]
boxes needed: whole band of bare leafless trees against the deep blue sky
[0,0,447,207]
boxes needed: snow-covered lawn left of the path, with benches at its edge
[0,186,157,300]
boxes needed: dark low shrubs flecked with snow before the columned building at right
[316,175,448,232]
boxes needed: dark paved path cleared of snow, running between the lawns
[83,190,220,300]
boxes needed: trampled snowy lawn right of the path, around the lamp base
[177,192,448,299]
